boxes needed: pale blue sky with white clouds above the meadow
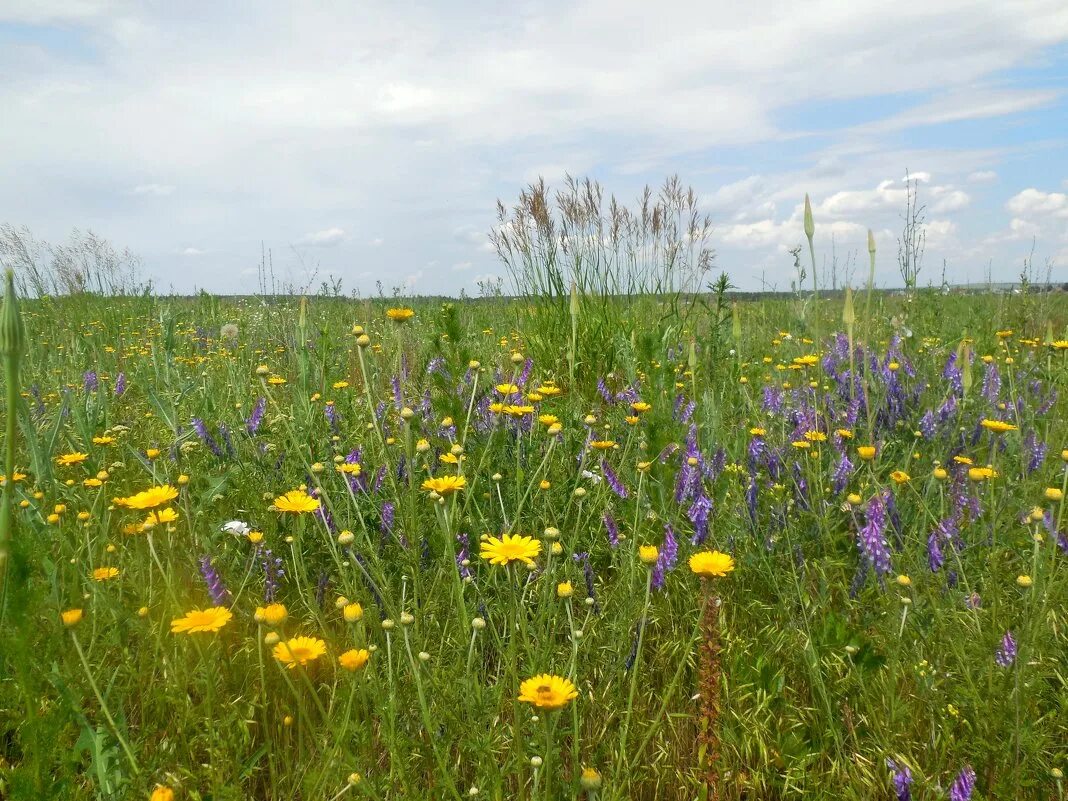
[0,0,1068,296]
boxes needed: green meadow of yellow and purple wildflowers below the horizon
[0,260,1068,801]
